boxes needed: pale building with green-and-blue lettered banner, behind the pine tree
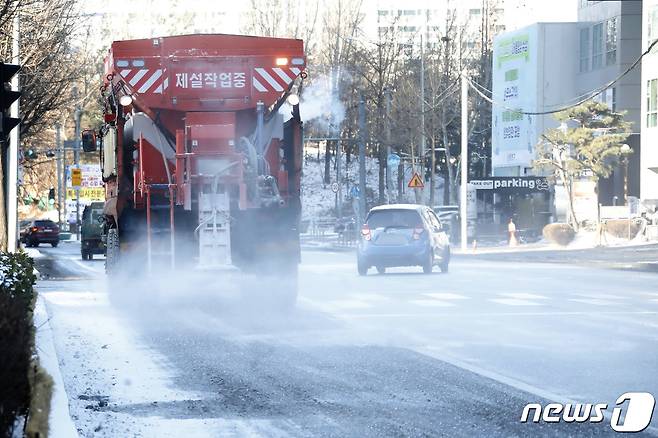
[492,0,642,205]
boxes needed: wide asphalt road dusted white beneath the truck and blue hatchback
[37,243,658,437]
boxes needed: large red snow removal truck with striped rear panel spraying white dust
[82,34,306,302]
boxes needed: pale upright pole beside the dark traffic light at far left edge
[7,13,21,252]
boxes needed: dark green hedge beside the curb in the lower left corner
[0,252,36,436]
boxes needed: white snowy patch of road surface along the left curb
[38,281,222,437]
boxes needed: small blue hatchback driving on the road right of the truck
[357,204,450,275]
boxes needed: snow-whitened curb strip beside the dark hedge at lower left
[34,294,79,438]
